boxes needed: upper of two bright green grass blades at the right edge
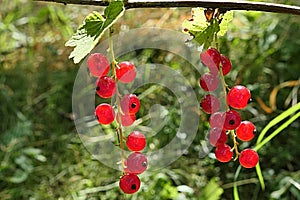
[256,103,300,145]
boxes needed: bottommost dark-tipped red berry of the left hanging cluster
[119,174,141,194]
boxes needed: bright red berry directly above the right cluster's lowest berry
[236,121,256,142]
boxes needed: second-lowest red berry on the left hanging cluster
[127,152,148,174]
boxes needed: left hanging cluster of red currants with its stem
[87,53,148,194]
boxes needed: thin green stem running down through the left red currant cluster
[108,27,125,173]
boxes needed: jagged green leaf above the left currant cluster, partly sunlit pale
[65,1,125,63]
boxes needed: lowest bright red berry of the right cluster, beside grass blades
[239,149,259,168]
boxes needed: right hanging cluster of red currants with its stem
[200,48,259,168]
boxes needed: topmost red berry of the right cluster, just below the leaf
[200,48,221,75]
